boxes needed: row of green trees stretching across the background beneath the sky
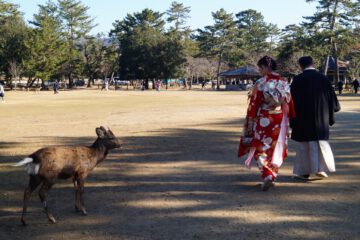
[0,0,360,87]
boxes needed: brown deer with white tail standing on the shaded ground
[14,126,121,226]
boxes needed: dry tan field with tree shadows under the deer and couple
[0,90,360,240]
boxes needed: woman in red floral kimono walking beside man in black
[238,56,295,191]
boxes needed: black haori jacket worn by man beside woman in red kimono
[290,69,340,142]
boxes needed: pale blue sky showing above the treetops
[7,0,316,34]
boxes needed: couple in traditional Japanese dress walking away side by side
[238,56,340,191]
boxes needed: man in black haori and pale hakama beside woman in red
[290,56,340,179]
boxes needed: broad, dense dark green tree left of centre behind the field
[111,9,185,87]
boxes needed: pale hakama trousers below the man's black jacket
[293,141,335,175]
